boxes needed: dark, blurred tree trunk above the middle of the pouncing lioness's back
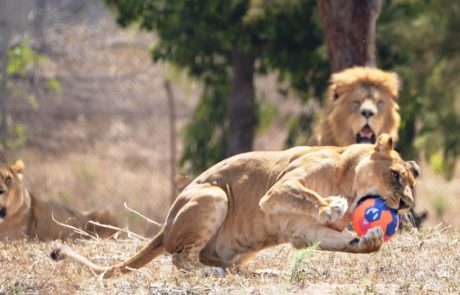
[226,50,257,156]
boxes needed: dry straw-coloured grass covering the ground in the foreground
[0,226,460,294]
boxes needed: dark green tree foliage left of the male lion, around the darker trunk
[104,0,329,172]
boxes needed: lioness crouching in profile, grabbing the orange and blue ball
[51,135,418,274]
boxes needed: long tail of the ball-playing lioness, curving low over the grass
[50,229,164,276]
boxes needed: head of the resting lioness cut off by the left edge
[0,160,24,223]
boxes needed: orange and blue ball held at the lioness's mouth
[352,196,399,242]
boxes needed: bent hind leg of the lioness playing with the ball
[165,185,228,270]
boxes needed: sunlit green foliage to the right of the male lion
[377,0,460,177]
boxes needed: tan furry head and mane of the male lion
[309,67,400,146]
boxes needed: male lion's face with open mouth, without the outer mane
[334,85,399,145]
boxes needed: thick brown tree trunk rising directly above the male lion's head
[317,0,383,72]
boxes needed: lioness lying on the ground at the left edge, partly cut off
[0,160,117,241]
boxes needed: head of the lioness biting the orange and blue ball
[353,134,420,214]
